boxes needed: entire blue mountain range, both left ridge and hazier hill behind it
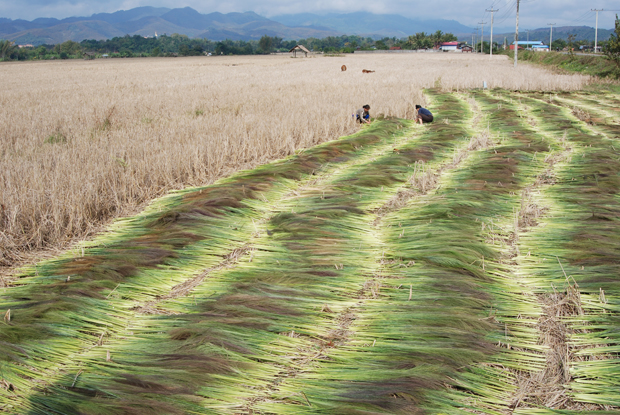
[0,7,471,46]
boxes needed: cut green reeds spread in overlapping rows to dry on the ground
[0,66,620,415]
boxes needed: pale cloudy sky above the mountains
[0,0,620,30]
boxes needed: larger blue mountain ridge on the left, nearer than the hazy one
[0,7,342,45]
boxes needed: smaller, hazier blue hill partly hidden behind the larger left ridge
[271,12,472,38]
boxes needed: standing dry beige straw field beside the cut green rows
[0,54,590,268]
